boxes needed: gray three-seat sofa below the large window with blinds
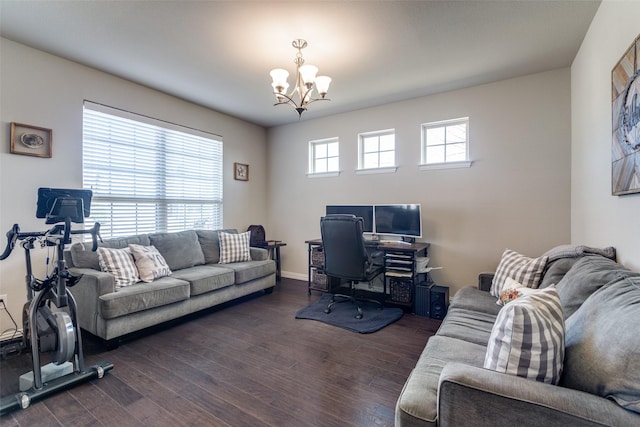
[64,230,276,346]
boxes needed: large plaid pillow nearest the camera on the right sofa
[484,286,564,384]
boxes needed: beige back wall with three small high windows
[267,68,571,298]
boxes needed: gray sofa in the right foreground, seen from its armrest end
[395,255,640,427]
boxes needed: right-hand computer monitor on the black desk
[374,203,422,238]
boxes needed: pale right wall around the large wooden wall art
[571,0,640,270]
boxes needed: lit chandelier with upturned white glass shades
[269,39,331,117]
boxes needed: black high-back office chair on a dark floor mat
[320,215,384,319]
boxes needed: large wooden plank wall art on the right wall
[611,35,640,196]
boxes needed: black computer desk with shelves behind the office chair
[305,239,432,308]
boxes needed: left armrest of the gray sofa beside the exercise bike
[69,267,116,335]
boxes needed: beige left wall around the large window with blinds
[0,39,267,331]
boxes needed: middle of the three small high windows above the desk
[358,129,396,169]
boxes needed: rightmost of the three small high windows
[422,117,469,166]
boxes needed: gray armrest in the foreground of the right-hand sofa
[438,363,640,427]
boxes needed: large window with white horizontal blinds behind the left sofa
[82,102,223,238]
